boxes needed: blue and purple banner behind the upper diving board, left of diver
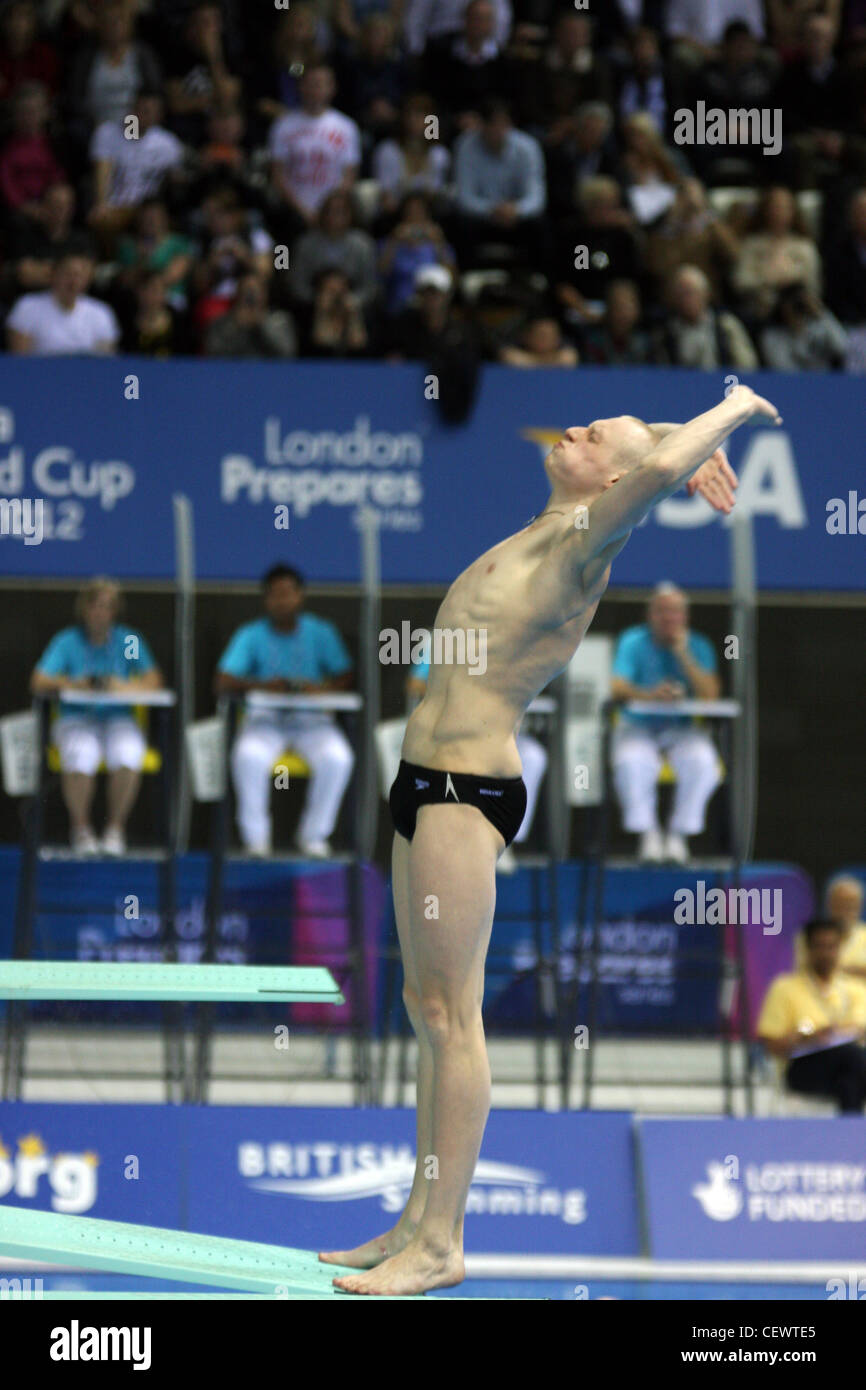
[0,847,385,1029]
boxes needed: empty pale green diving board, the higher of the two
[0,960,345,1004]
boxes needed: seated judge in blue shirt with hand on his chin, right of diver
[610,584,720,863]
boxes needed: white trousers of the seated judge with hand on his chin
[612,726,720,835]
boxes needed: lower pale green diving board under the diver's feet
[0,1204,411,1300]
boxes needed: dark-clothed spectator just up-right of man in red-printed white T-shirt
[338,13,406,147]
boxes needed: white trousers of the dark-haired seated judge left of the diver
[232,713,354,849]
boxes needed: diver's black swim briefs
[388,759,527,845]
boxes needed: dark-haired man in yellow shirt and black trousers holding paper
[756,917,866,1113]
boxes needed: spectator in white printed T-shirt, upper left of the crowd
[89,89,185,247]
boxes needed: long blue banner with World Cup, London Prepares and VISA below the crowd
[0,357,866,589]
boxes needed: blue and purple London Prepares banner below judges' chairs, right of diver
[475,863,813,1034]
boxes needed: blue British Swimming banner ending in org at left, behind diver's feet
[0,1102,638,1255]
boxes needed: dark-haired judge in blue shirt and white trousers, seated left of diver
[217,564,354,859]
